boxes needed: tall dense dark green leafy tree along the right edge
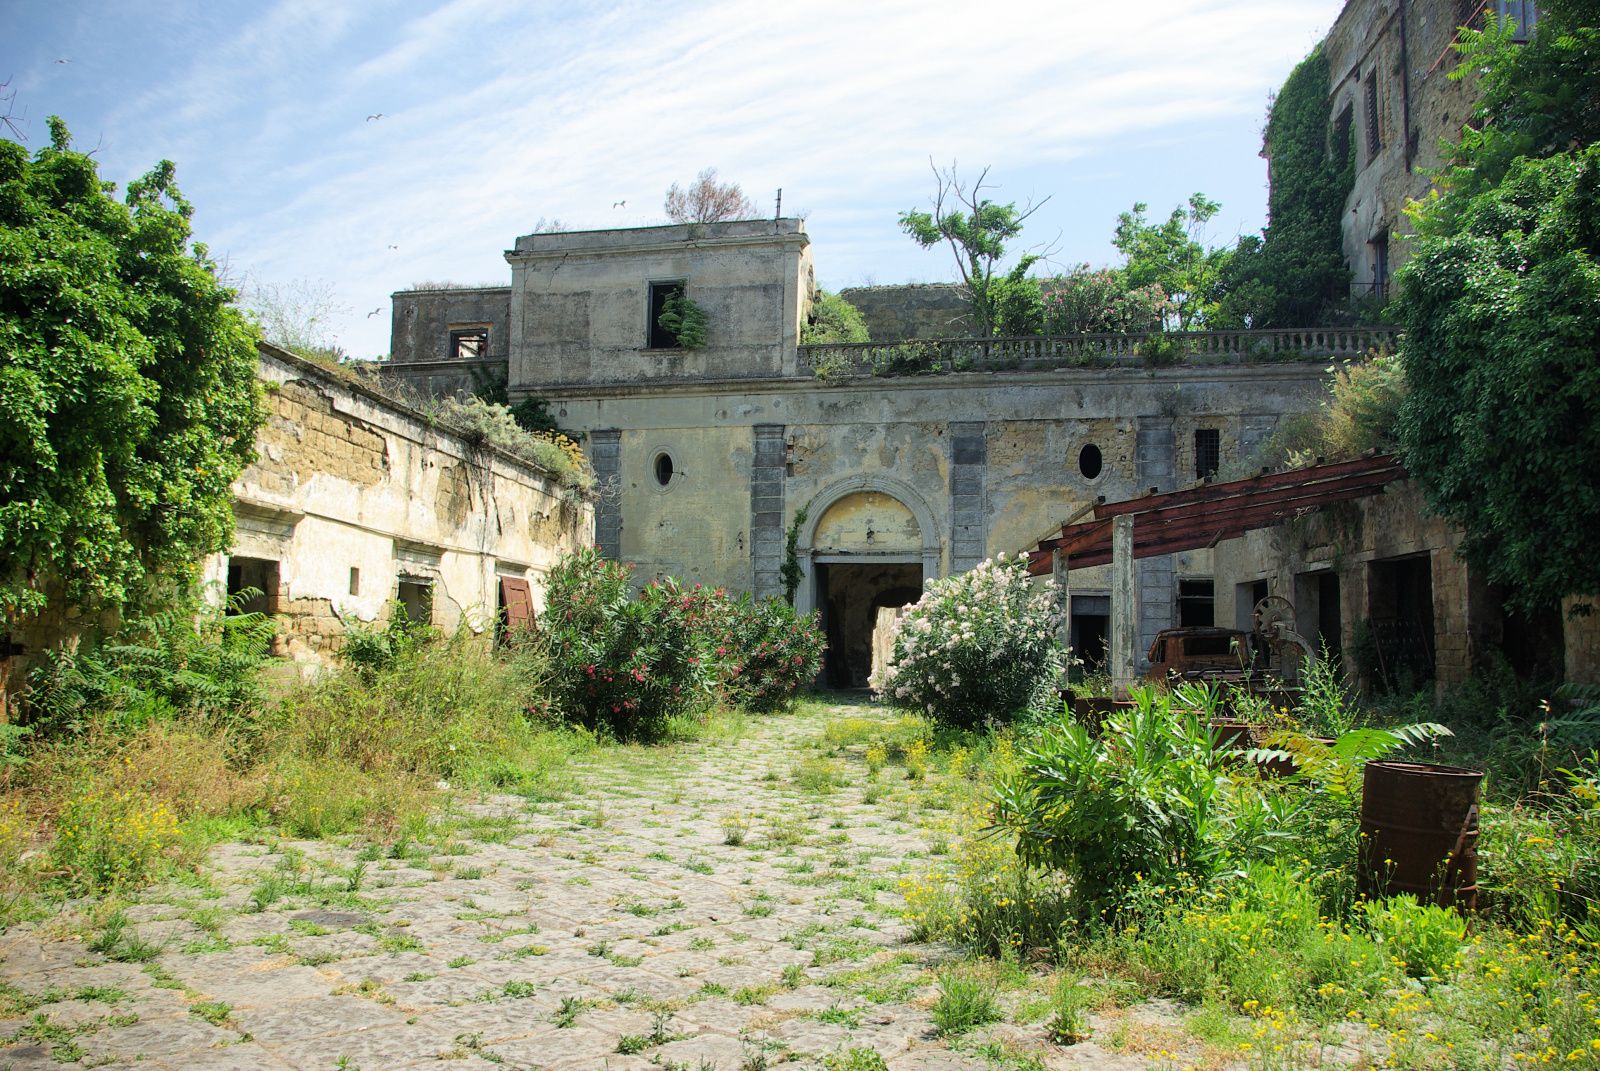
[1397,2,1600,610]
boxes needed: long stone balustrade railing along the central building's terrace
[798,327,1398,379]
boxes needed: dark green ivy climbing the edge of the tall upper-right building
[1214,45,1355,328]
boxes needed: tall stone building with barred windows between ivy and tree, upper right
[1325,0,1539,299]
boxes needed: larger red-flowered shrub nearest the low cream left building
[536,548,726,740]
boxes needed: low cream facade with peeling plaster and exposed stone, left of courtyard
[206,346,594,666]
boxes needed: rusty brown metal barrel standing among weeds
[1360,762,1483,911]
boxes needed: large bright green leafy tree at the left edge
[0,118,262,628]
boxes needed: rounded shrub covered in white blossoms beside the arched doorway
[877,556,1066,728]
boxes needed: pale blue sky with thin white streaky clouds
[0,0,1341,357]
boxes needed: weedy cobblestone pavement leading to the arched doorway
[0,708,1177,1071]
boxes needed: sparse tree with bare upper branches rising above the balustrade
[899,160,1050,336]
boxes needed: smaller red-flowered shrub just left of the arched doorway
[718,594,826,711]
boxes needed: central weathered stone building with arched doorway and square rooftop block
[387,219,1381,684]
